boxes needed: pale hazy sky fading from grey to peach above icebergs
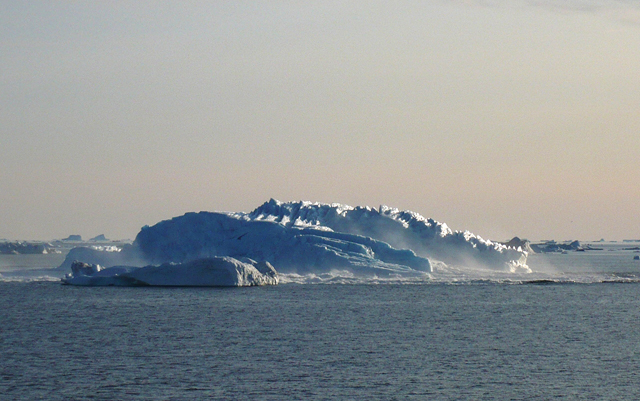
[0,0,640,240]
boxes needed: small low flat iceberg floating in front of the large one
[62,257,278,287]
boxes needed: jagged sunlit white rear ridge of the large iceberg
[243,199,527,270]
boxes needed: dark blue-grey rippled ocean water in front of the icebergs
[0,281,640,400]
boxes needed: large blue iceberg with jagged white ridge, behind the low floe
[61,199,528,277]
